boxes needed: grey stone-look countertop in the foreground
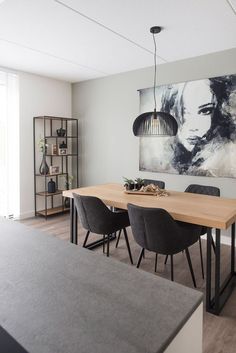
[0,220,202,353]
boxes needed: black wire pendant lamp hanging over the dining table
[133,26,178,137]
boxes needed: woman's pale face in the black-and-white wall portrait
[178,80,215,151]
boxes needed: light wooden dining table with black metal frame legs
[63,183,236,315]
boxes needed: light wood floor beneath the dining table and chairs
[21,214,236,353]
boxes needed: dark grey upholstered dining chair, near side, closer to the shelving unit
[73,193,133,264]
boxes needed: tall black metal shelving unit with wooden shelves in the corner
[33,116,79,219]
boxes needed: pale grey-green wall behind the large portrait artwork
[72,49,236,204]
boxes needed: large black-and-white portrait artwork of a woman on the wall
[139,75,236,178]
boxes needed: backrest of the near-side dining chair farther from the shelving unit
[128,204,185,255]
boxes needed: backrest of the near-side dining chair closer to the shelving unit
[73,193,114,234]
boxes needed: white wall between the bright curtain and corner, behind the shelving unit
[18,72,71,218]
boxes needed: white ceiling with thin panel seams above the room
[0,0,236,82]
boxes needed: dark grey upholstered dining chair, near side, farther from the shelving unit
[128,204,201,287]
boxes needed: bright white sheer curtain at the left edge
[0,70,20,218]
